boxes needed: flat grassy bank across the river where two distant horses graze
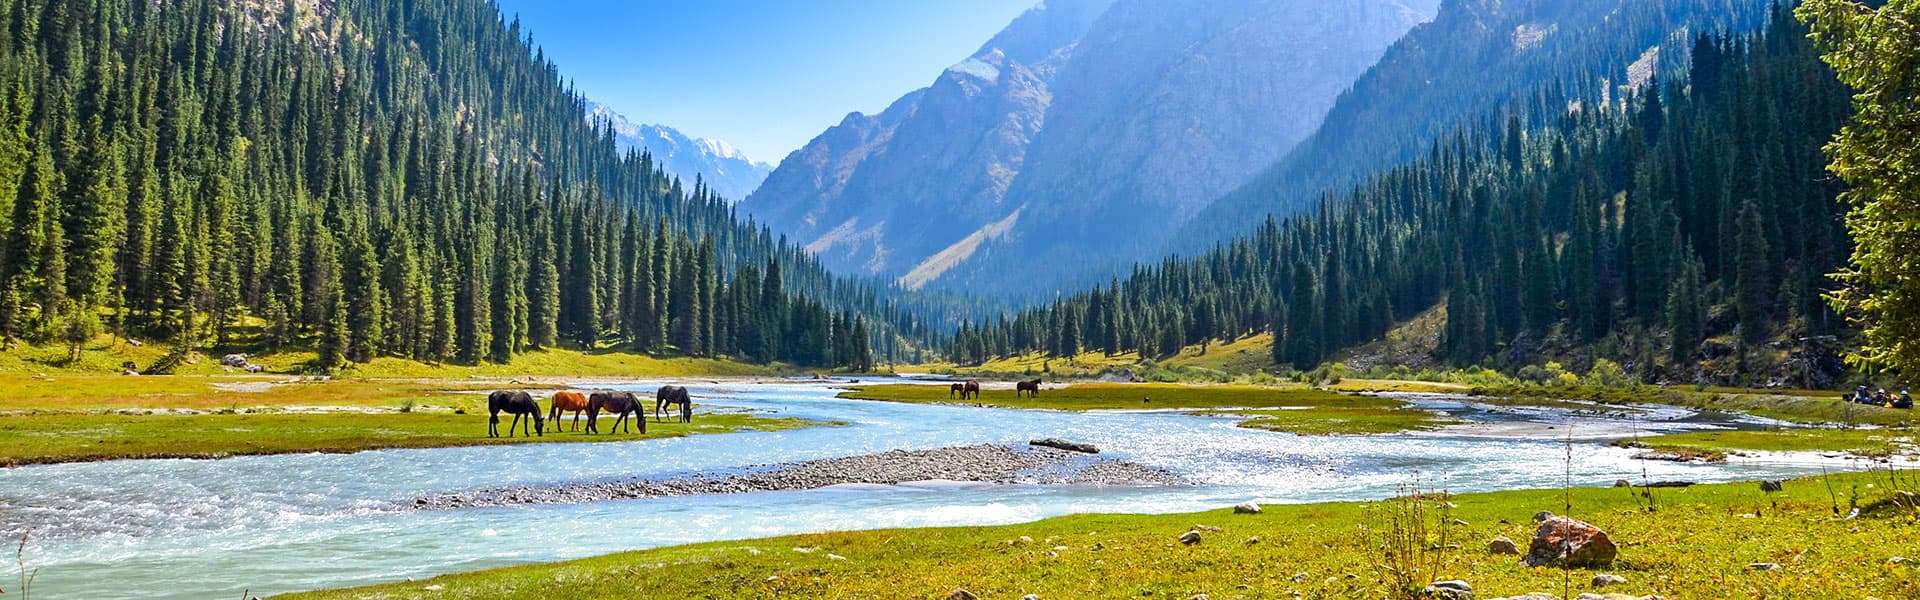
[841,383,1448,435]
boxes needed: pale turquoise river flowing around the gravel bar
[0,383,1858,600]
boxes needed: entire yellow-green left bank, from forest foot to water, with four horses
[0,373,820,467]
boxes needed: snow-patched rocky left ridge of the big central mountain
[743,0,1112,277]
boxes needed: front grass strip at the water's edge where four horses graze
[0,410,820,467]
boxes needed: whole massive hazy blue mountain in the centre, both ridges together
[743,0,1440,288]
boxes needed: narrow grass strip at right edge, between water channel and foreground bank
[1615,429,1914,460]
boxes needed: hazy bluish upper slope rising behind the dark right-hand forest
[1173,0,1772,250]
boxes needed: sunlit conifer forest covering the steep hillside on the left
[0,0,937,369]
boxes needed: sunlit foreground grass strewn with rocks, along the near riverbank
[286,471,1920,600]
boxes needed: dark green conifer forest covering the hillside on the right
[950,8,1851,385]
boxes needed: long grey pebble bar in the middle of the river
[411,444,1187,510]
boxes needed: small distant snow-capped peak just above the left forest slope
[588,102,774,202]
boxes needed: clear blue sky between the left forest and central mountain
[497,0,1039,163]
